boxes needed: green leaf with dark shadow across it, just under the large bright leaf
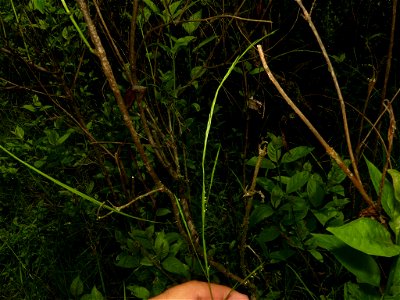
[312,234,381,286]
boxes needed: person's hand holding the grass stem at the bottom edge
[150,280,249,300]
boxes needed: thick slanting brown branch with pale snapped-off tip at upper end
[257,45,375,208]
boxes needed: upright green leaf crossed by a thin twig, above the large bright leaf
[365,158,398,218]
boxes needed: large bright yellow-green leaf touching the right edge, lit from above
[327,218,400,257]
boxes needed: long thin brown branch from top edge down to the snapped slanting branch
[295,0,362,185]
